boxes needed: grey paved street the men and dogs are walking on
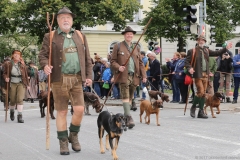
[0,97,240,160]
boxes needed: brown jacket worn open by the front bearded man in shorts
[38,31,92,83]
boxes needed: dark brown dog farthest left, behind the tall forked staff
[38,91,55,119]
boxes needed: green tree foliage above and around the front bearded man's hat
[2,0,141,42]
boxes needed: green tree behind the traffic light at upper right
[140,0,240,51]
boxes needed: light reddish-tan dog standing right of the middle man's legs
[140,100,163,126]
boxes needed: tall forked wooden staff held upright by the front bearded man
[46,12,54,150]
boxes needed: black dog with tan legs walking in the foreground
[97,111,127,160]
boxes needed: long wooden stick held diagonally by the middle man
[103,17,152,107]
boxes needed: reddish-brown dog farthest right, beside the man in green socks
[204,92,223,118]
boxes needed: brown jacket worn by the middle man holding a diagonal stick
[111,41,147,85]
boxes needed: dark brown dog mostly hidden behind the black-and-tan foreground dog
[71,92,103,115]
